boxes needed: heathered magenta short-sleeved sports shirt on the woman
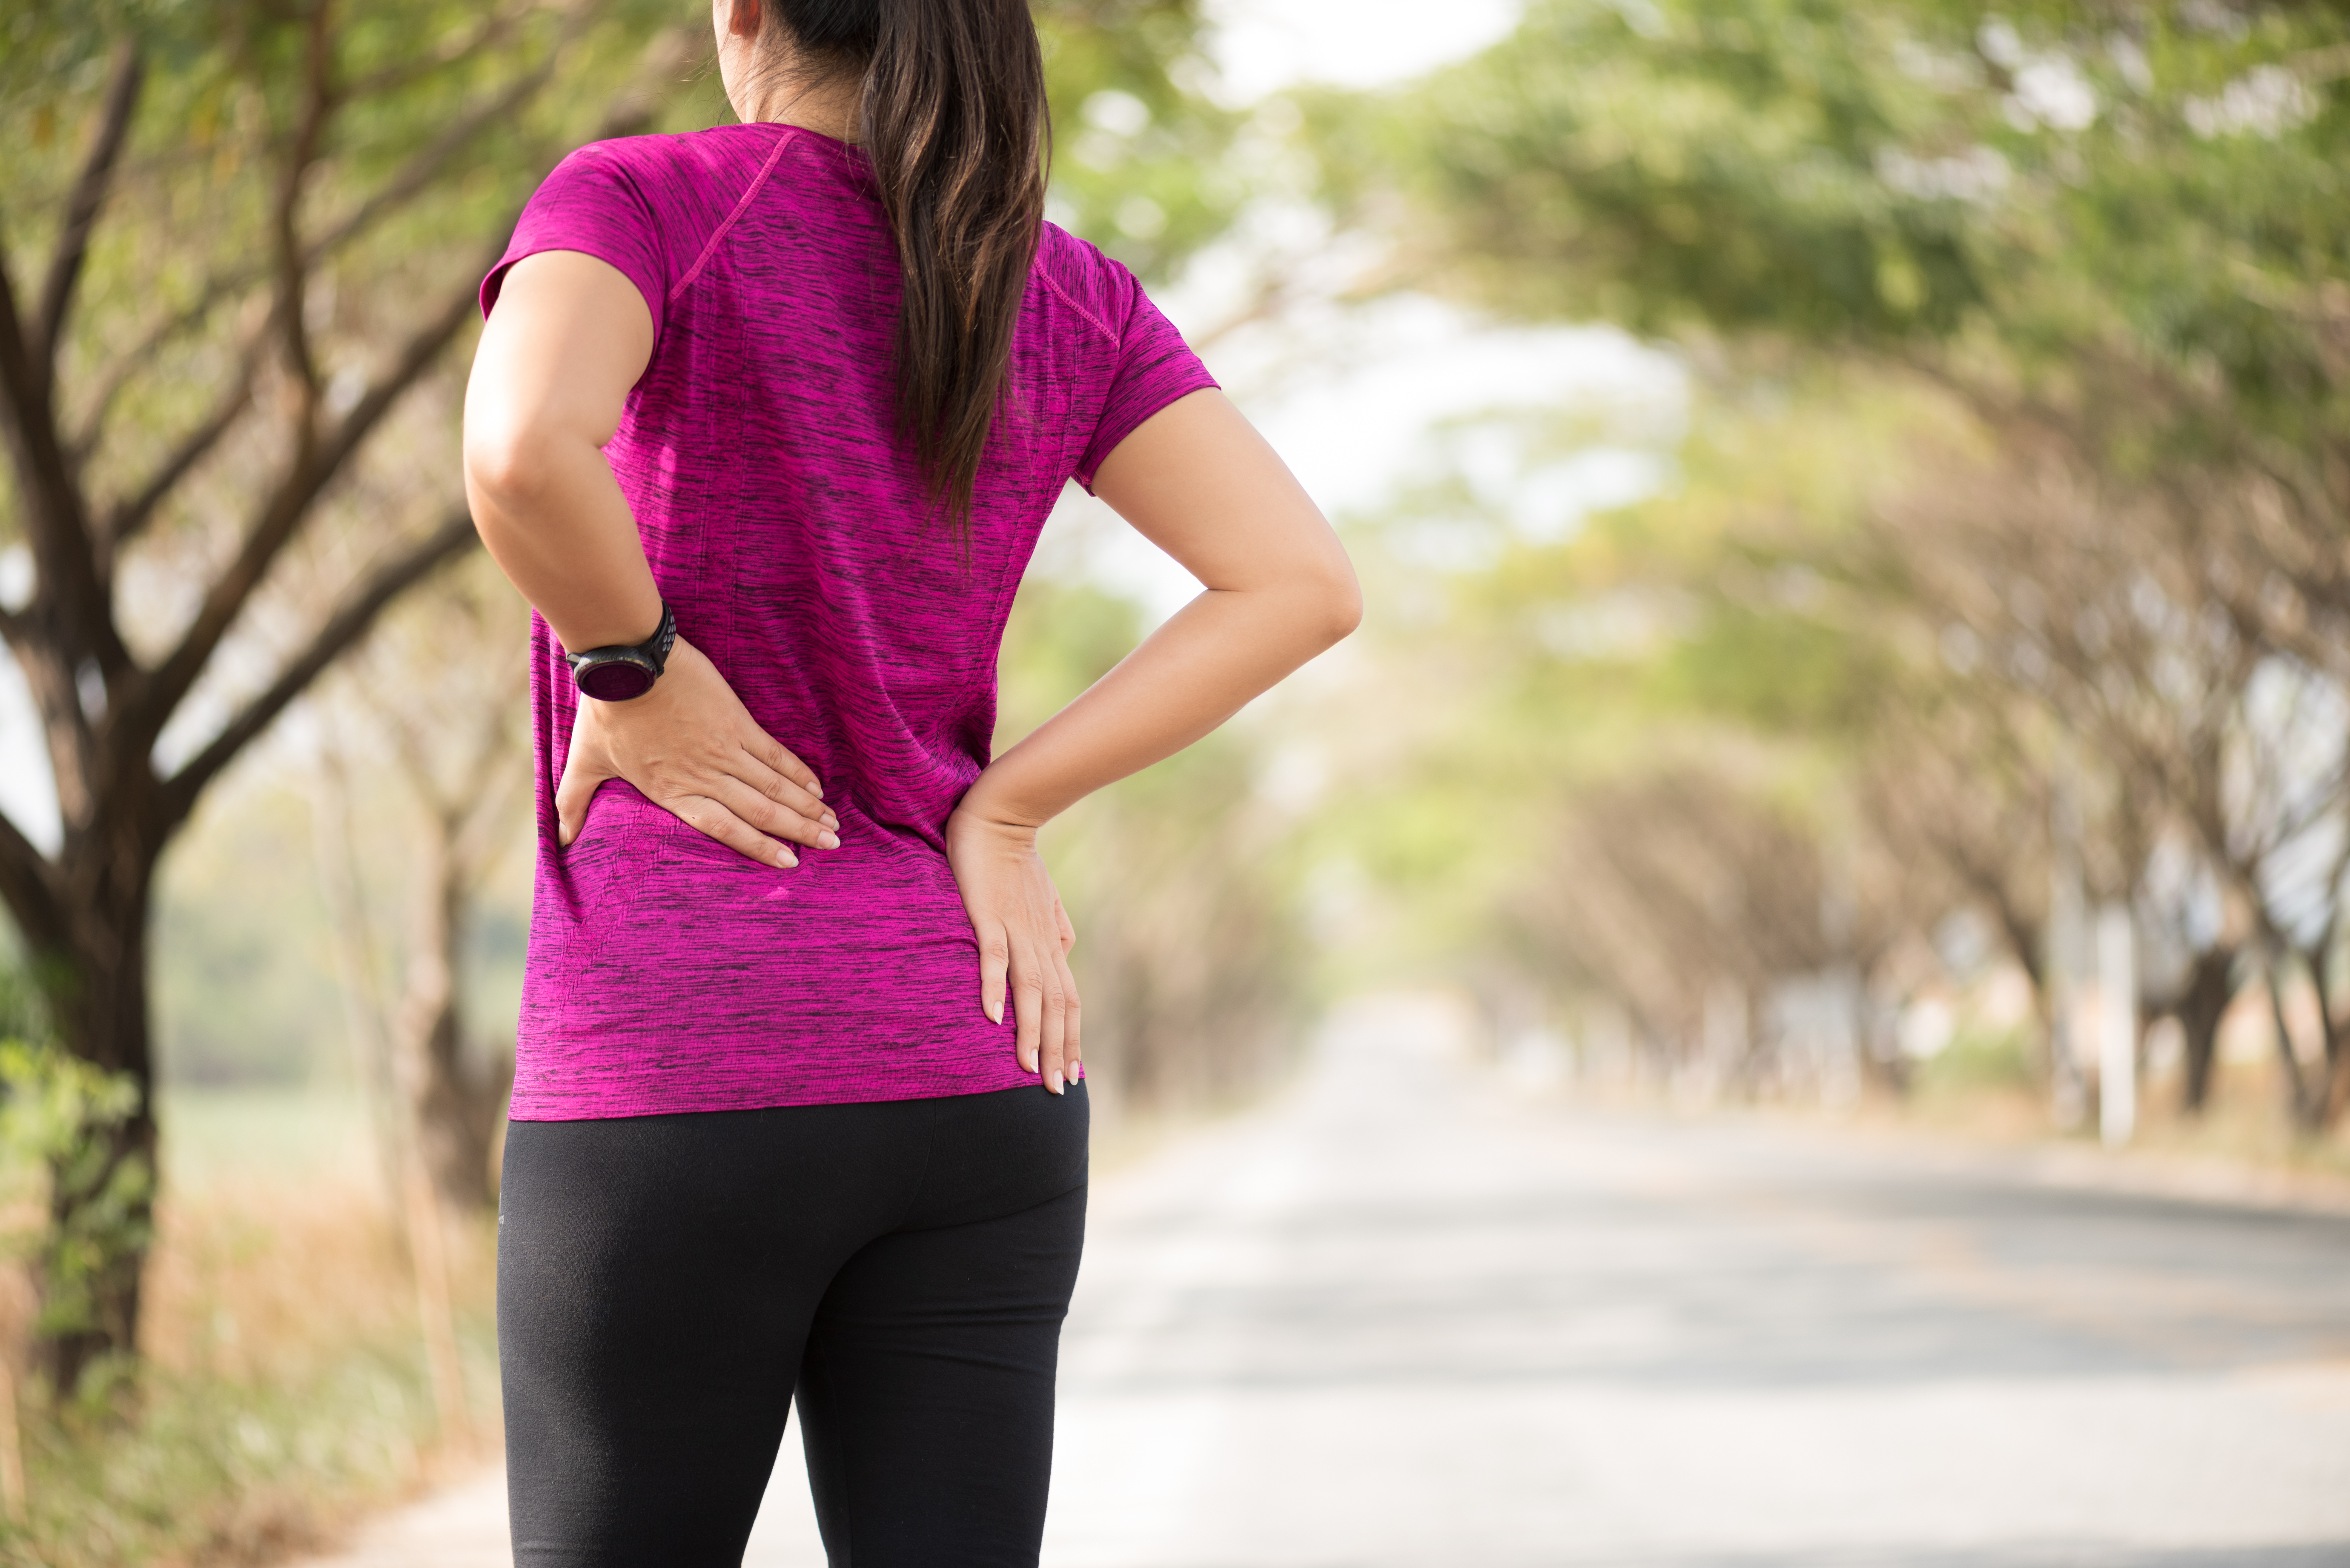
[482,125,1215,1122]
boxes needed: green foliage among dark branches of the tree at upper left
[0,0,674,435]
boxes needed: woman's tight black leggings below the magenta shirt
[498,1084,1088,1568]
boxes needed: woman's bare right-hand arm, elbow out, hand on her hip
[947,390,1363,1088]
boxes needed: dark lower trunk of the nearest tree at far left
[35,870,160,1396]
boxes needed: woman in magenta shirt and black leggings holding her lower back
[465,0,1358,1568]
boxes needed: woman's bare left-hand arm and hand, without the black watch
[465,252,839,865]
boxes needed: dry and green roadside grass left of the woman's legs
[0,1091,498,1568]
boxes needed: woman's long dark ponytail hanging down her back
[764,0,1053,534]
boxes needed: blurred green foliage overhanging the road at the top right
[1363,0,2350,472]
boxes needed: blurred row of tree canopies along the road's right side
[1311,0,2350,1126]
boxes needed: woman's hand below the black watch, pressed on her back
[555,637,841,867]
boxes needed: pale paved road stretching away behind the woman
[294,1013,2350,1568]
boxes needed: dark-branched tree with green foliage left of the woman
[0,0,682,1389]
